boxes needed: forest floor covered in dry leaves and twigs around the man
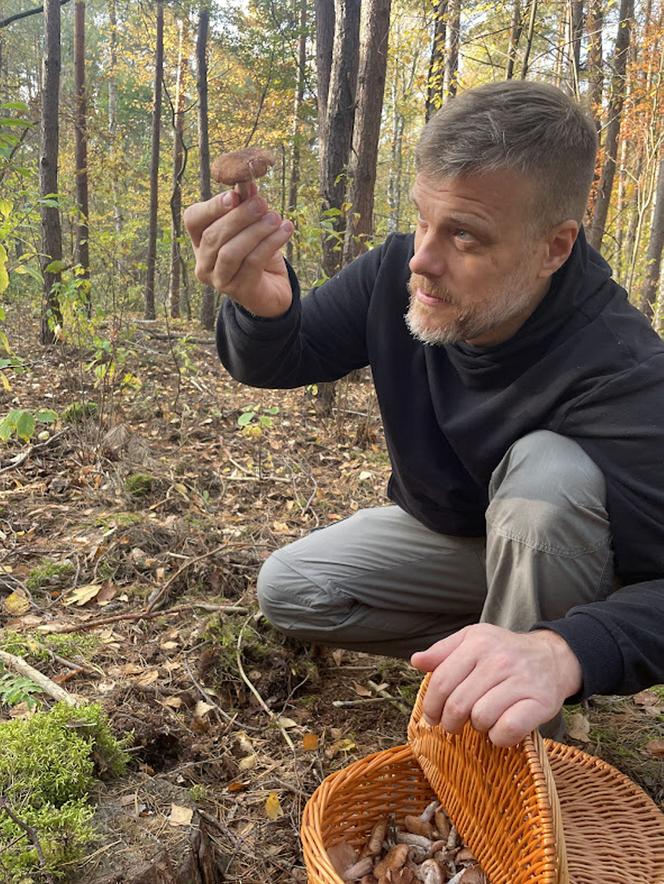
[0,314,664,884]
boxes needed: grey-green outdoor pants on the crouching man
[258,430,613,657]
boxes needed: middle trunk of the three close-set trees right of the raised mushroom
[319,0,360,276]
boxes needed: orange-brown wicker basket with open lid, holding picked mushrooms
[301,680,664,884]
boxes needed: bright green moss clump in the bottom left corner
[0,704,127,884]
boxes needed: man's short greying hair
[415,80,597,235]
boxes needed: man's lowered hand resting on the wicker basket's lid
[411,623,582,746]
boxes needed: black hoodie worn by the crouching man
[217,230,664,699]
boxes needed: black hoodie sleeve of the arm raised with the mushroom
[217,239,389,389]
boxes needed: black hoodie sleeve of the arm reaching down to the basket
[533,349,664,700]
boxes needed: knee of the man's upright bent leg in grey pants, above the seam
[486,430,610,555]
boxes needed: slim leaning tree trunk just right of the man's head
[589,0,634,250]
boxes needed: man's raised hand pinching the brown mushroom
[184,186,293,318]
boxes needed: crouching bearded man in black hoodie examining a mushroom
[185,81,664,746]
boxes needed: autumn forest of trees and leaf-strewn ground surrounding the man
[0,0,664,884]
